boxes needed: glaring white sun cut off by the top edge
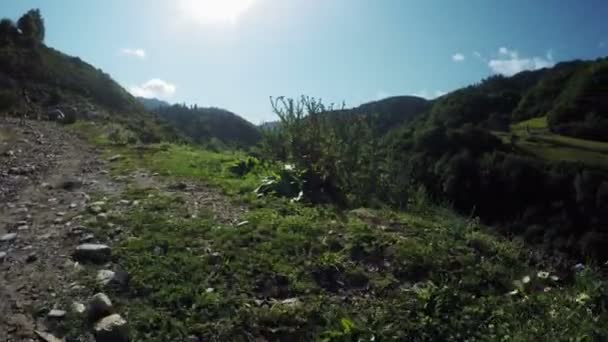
[178,0,255,24]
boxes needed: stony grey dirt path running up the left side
[0,122,123,341]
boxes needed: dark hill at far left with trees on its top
[0,10,173,141]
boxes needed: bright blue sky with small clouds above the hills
[0,0,608,123]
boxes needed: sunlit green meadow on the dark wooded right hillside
[495,117,608,169]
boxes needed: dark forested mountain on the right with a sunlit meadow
[381,58,608,260]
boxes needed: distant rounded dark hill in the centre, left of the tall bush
[155,104,261,147]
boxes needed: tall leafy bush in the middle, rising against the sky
[263,97,384,205]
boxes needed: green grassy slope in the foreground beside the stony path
[66,125,608,341]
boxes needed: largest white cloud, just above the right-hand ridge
[488,46,555,76]
